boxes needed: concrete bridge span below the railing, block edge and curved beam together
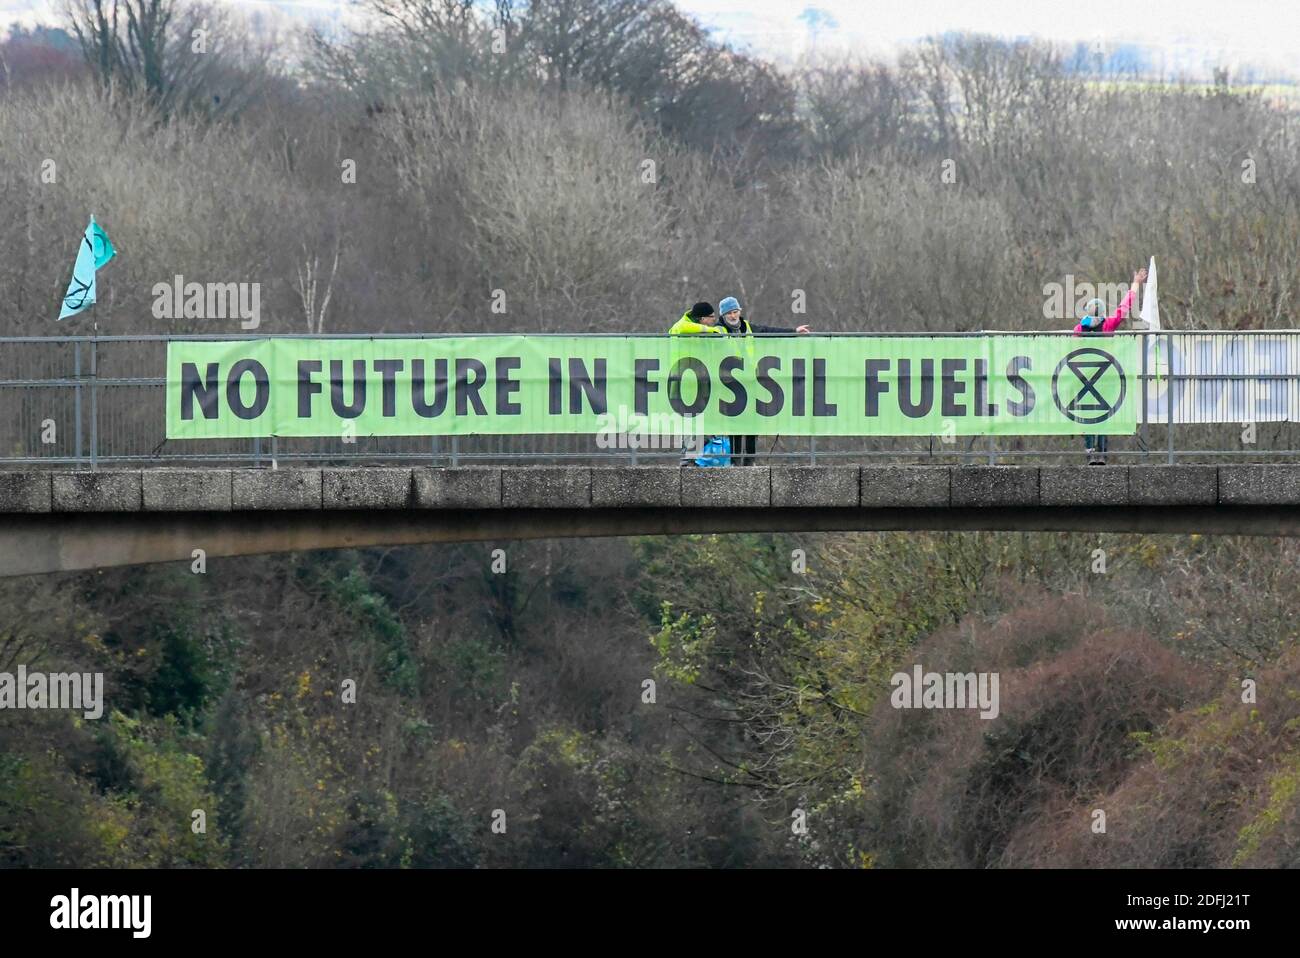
[0,464,1300,576]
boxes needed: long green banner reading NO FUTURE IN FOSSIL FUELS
[166,335,1140,439]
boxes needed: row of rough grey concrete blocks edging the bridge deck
[0,464,1300,513]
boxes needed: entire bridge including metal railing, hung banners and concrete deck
[0,330,1300,576]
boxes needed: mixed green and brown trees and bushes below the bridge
[0,514,1300,868]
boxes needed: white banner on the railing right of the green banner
[1138,330,1300,424]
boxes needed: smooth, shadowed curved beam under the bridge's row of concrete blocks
[0,506,1300,576]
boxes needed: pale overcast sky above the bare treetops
[0,0,1300,75]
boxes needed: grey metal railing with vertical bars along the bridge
[0,330,1300,469]
